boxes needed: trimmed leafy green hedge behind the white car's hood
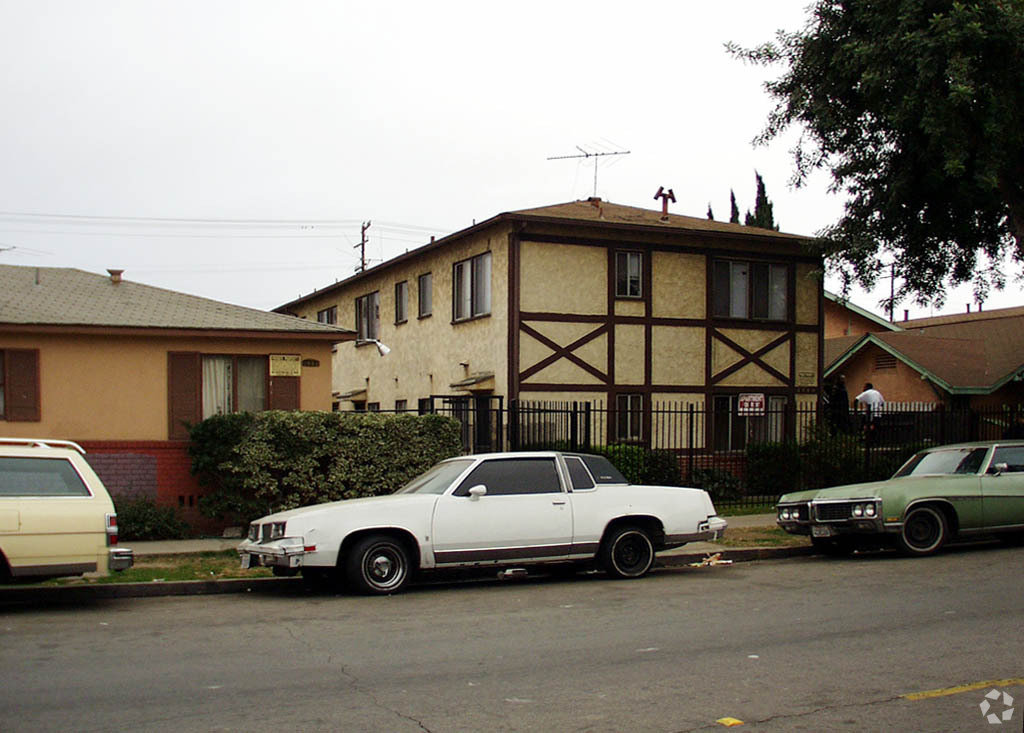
[188,411,462,525]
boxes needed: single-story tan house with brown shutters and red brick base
[0,265,355,526]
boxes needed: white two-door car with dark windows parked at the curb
[239,451,726,594]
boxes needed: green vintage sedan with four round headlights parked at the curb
[777,440,1024,556]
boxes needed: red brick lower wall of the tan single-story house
[78,440,224,534]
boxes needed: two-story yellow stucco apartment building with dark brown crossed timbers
[276,199,823,449]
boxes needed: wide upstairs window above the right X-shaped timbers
[712,260,788,320]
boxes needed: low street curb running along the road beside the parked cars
[0,547,815,607]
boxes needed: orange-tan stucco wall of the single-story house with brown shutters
[0,334,331,440]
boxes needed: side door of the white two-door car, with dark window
[433,458,572,565]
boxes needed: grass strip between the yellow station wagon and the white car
[46,550,273,586]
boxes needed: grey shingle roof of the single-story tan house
[0,265,352,340]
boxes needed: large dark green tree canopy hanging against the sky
[729,0,1024,304]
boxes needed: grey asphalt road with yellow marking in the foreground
[0,548,1024,732]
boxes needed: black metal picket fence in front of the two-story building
[385,396,1024,507]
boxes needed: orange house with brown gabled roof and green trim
[825,298,1024,408]
